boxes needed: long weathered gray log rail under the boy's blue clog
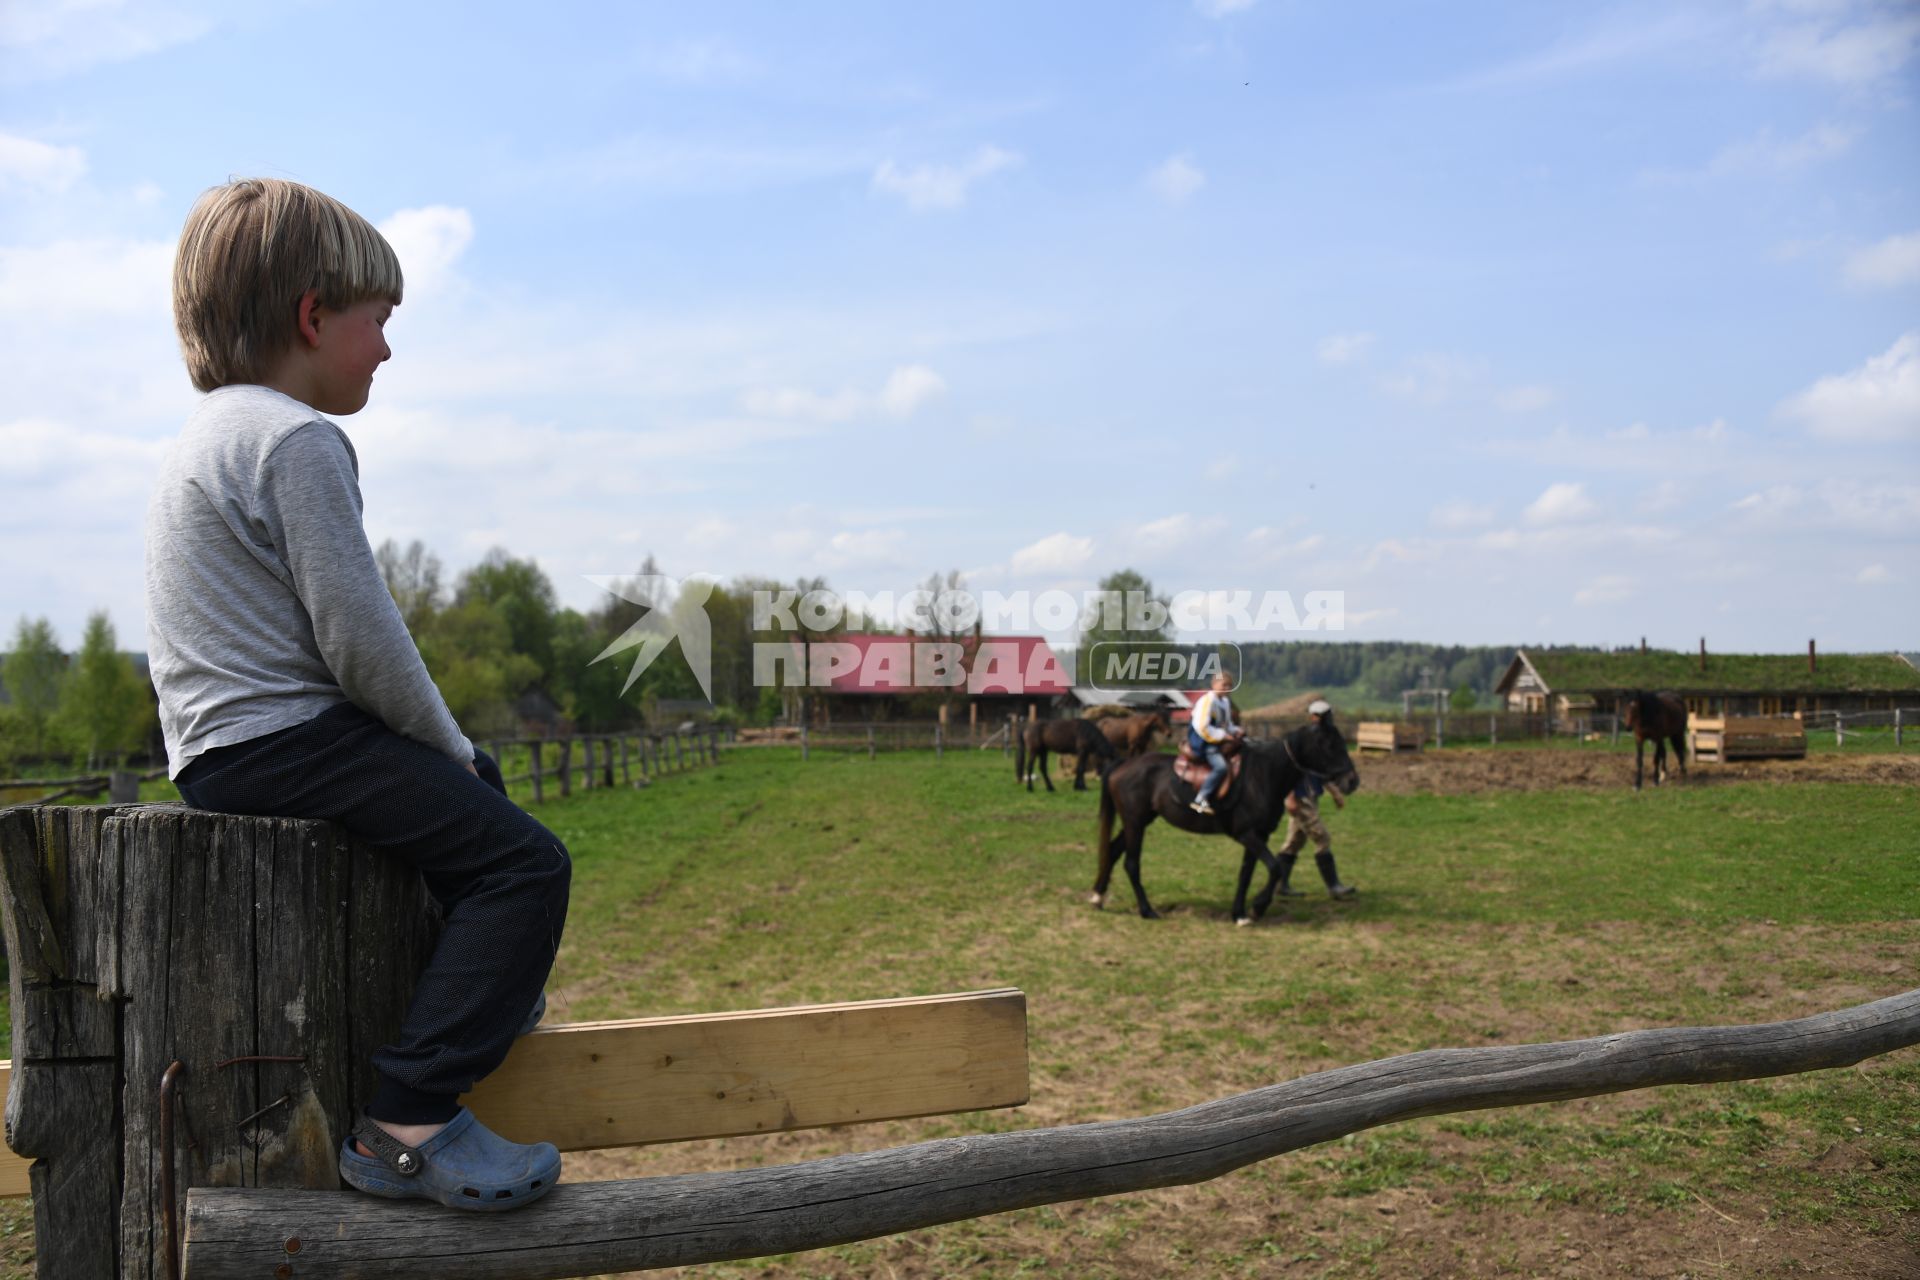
[186,990,1920,1280]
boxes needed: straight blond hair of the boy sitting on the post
[173,178,403,391]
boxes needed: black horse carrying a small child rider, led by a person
[1089,714,1359,925]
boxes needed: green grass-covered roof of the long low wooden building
[1521,649,1920,693]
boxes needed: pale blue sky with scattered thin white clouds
[0,0,1920,651]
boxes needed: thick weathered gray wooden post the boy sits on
[0,806,438,1280]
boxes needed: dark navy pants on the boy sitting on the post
[175,702,572,1125]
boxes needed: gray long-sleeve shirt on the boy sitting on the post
[146,386,474,777]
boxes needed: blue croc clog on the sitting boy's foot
[340,1107,561,1213]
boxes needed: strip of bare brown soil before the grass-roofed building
[1354,747,1920,796]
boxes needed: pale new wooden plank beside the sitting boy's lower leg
[467,990,1027,1151]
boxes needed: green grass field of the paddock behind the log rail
[0,748,1920,1278]
